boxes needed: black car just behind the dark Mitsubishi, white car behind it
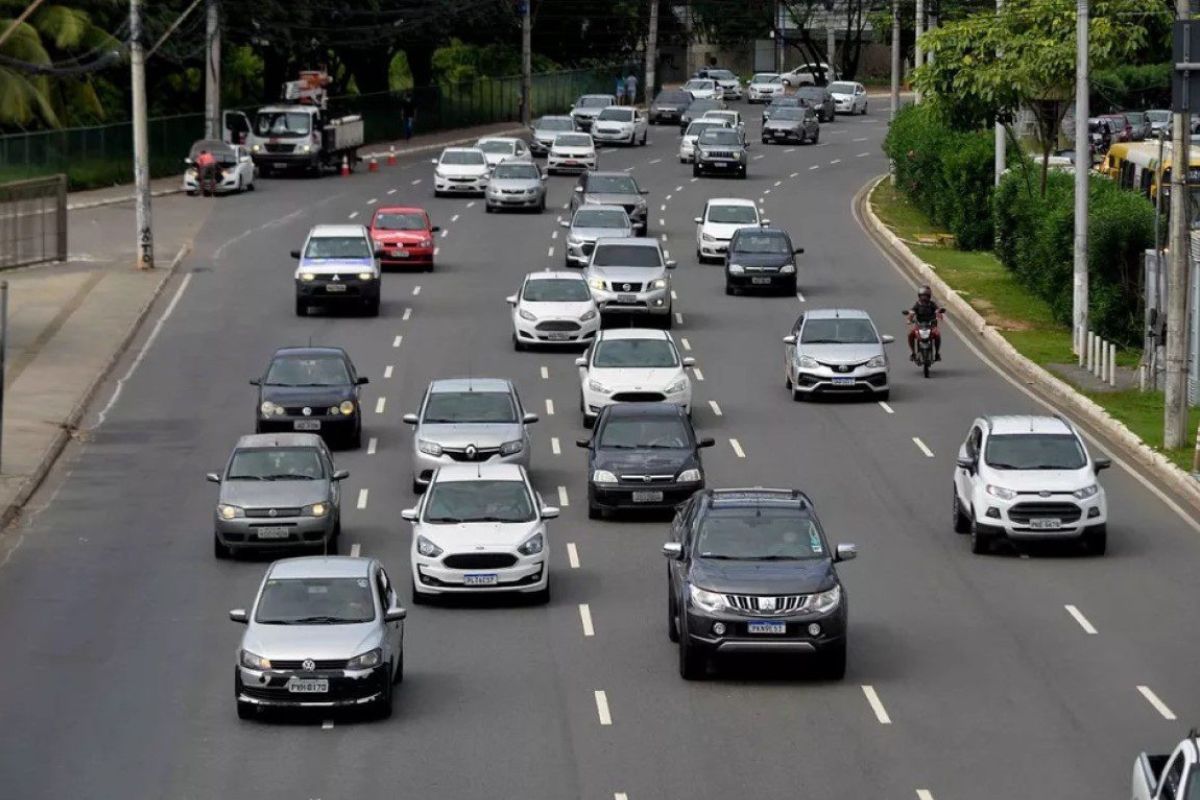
[577,403,714,519]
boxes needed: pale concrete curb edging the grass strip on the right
[856,175,1200,511]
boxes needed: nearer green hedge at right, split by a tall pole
[992,169,1154,345]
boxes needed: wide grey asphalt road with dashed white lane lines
[0,108,1200,800]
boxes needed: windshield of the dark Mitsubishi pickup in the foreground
[692,506,827,561]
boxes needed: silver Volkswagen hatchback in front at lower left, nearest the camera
[229,555,408,720]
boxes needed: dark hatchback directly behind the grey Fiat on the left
[250,347,367,447]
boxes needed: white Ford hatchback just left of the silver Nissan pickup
[508,271,600,350]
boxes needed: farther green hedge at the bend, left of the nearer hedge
[883,106,995,249]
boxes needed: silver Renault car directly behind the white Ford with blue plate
[404,378,538,493]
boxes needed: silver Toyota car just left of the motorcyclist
[784,308,893,401]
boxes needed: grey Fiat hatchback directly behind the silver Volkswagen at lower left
[206,433,350,559]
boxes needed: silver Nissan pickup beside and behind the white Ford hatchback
[583,237,676,330]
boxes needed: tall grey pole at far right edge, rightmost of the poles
[1163,0,1200,449]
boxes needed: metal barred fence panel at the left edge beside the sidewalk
[0,175,67,270]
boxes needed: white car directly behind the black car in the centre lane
[575,327,696,428]
